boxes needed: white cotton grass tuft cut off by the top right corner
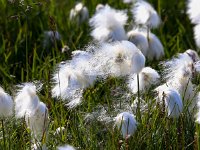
[187,0,200,24]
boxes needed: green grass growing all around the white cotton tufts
[0,0,200,150]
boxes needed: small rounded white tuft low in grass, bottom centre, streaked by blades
[115,112,137,138]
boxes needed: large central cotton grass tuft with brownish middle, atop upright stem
[91,41,145,77]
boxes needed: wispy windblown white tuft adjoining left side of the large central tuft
[52,59,96,108]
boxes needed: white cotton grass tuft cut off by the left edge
[0,87,13,118]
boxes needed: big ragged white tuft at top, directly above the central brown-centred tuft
[89,5,128,42]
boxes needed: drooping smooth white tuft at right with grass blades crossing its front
[156,86,183,118]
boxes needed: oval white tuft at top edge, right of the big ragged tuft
[132,1,160,28]
